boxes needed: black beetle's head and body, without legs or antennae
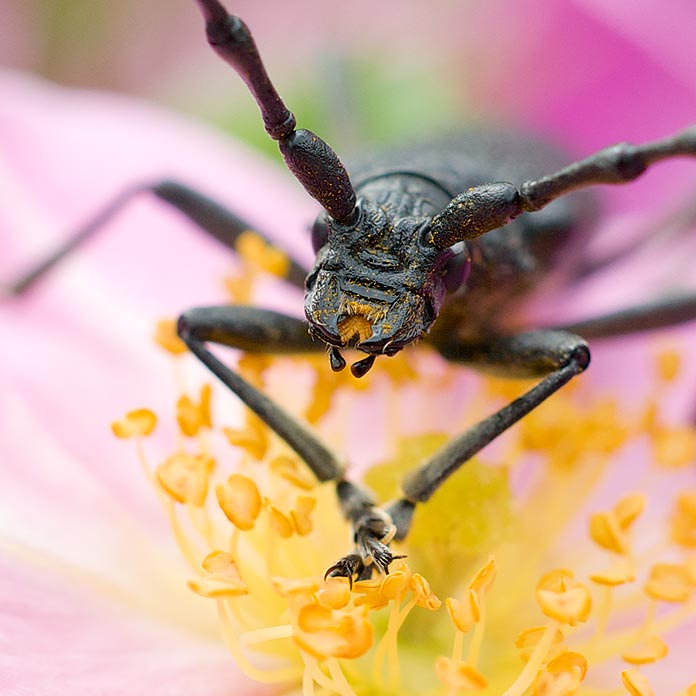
[305,129,588,364]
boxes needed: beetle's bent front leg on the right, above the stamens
[387,329,590,540]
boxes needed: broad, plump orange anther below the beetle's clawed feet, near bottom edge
[293,604,374,659]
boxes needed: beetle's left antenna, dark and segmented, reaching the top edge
[196,0,356,222]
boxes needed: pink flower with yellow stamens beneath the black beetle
[0,3,694,695]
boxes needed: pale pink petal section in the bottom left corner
[0,559,263,696]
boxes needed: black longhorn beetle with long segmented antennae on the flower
[11,0,696,582]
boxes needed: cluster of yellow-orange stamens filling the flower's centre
[114,278,696,696]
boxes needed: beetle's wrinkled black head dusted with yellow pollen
[305,200,468,376]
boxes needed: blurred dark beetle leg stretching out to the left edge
[3,180,308,295]
